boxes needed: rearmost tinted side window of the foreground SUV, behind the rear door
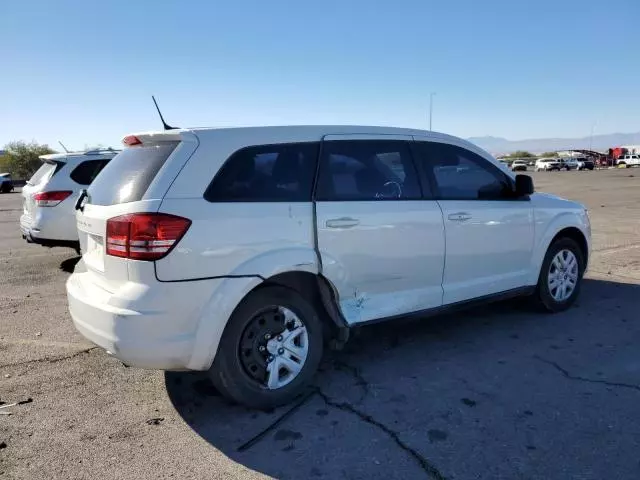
[204,143,318,202]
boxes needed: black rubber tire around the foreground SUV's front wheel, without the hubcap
[533,237,584,312]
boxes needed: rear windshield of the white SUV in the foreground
[87,142,179,205]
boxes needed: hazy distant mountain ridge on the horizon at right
[468,132,640,155]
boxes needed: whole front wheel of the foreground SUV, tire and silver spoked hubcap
[534,237,584,312]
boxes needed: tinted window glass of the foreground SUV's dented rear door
[316,140,421,201]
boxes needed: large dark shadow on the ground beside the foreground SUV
[165,280,640,479]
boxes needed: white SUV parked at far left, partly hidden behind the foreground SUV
[20,149,118,249]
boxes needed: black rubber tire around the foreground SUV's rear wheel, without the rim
[209,286,323,410]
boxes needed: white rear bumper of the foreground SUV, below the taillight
[67,262,226,370]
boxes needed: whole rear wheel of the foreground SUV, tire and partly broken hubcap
[209,286,323,409]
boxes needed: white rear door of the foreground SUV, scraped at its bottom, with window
[316,135,444,324]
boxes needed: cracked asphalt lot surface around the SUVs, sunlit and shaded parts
[0,169,640,480]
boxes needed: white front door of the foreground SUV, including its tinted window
[415,141,534,305]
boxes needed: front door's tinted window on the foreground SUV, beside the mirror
[417,142,513,200]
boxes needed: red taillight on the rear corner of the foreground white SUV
[106,213,191,260]
